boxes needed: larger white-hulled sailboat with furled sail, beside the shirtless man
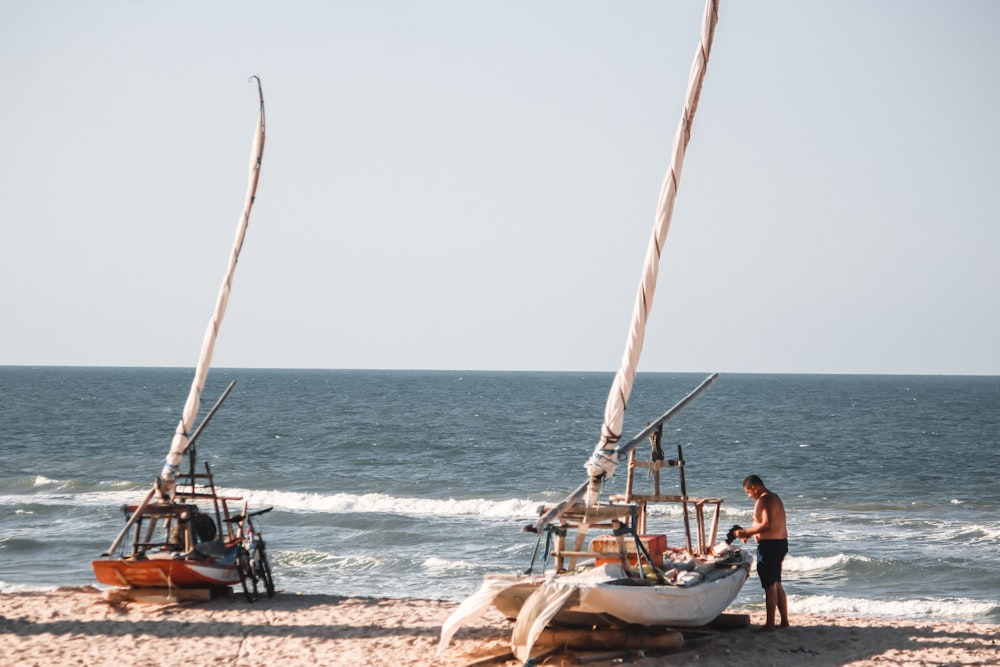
[439,0,752,660]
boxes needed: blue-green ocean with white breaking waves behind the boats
[0,367,1000,623]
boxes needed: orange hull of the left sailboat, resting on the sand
[91,558,240,588]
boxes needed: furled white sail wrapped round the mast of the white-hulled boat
[586,0,719,479]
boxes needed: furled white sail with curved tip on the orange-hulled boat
[159,76,264,494]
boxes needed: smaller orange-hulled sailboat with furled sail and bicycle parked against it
[91,77,274,600]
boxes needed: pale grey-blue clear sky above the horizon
[0,0,1000,375]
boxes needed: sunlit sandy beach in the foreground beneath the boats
[0,586,1000,667]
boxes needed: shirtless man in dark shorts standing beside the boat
[735,475,788,632]
